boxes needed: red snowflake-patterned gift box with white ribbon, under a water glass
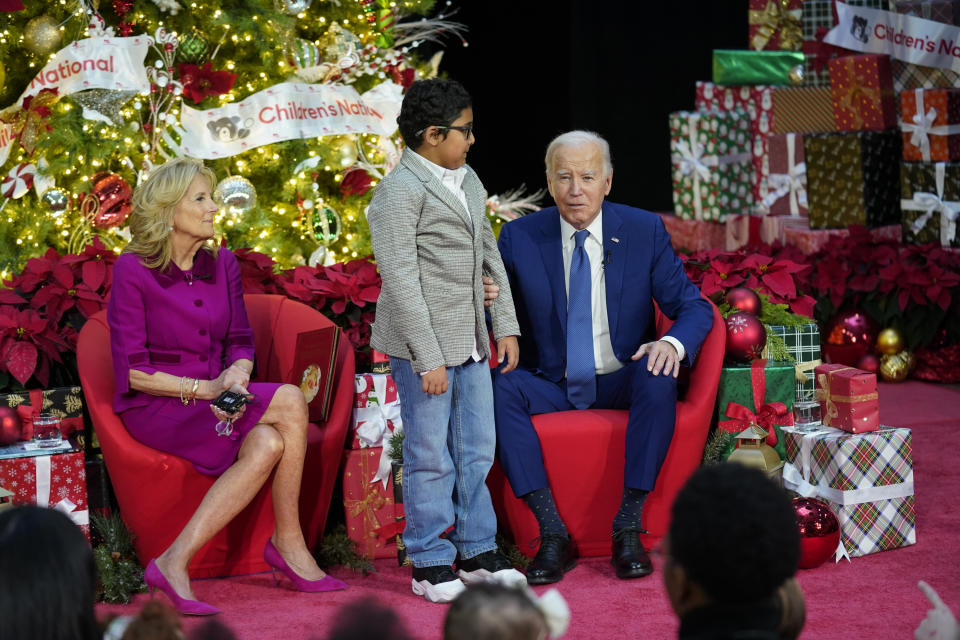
[0,451,90,541]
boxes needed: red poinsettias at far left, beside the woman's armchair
[0,238,116,388]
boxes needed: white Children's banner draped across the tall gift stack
[823,2,960,72]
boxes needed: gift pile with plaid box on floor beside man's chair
[715,323,916,560]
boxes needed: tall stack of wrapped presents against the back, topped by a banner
[664,0,960,253]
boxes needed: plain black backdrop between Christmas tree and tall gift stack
[434,0,747,211]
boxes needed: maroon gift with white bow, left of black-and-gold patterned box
[763,133,809,216]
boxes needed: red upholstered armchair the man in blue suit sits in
[487,307,726,557]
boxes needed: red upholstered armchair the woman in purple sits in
[77,294,354,578]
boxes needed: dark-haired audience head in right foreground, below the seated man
[663,463,803,638]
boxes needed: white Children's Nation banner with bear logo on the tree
[179,81,403,160]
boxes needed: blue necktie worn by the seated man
[567,229,597,409]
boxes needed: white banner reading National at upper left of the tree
[0,35,153,164]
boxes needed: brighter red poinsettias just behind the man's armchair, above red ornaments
[681,249,816,318]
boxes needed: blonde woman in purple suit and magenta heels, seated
[107,158,346,615]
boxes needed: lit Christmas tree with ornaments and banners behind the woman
[0,0,523,278]
